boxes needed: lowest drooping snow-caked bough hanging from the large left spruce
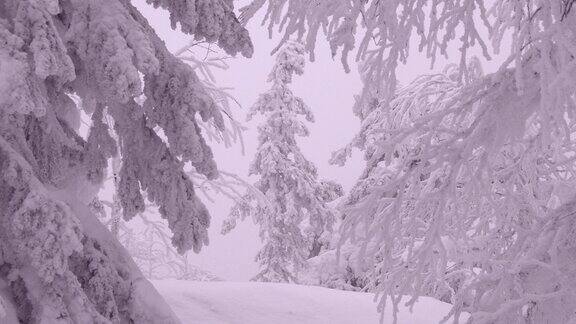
[112,102,210,253]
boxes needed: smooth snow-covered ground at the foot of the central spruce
[153,280,466,324]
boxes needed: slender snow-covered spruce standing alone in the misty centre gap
[223,42,342,282]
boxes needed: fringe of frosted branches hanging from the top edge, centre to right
[240,0,574,105]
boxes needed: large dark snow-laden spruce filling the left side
[0,0,252,323]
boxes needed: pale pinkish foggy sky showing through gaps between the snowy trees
[133,0,497,281]
